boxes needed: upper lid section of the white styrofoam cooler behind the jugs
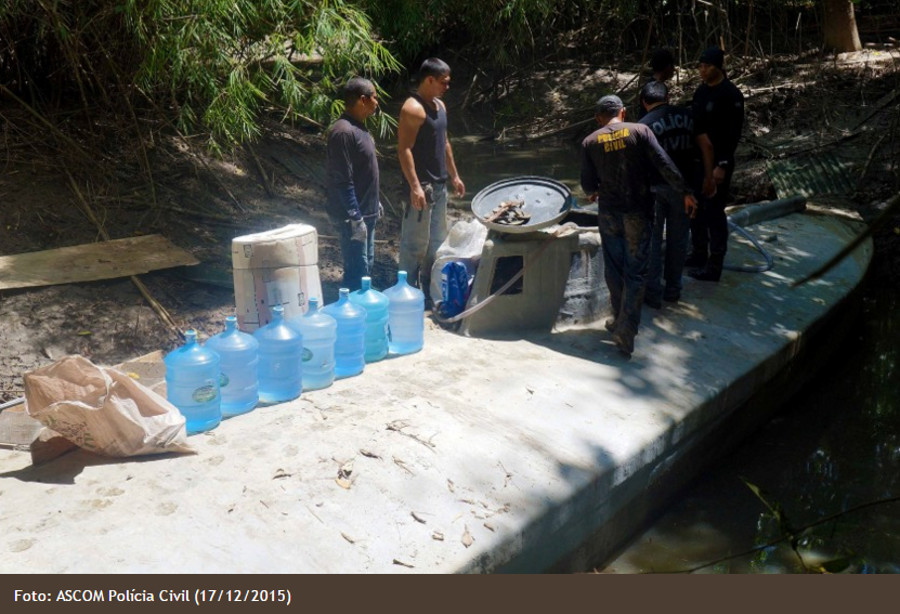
[231,224,319,269]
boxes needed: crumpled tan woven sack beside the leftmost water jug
[24,356,194,457]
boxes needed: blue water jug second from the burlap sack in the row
[206,316,259,418]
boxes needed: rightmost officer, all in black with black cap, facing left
[685,47,744,281]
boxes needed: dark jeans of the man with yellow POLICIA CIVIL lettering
[597,205,653,338]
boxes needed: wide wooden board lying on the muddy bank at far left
[0,234,199,289]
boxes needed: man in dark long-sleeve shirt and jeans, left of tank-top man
[326,77,381,291]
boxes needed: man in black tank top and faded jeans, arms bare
[397,58,466,295]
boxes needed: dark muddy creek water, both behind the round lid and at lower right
[454,138,900,573]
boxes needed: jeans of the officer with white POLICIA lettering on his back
[647,185,691,299]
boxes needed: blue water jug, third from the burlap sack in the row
[253,305,303,403]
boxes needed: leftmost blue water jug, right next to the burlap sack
[163,329,222,435]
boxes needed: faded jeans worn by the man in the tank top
[399,183,448,291]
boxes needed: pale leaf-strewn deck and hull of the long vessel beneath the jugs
[0,213,872,573]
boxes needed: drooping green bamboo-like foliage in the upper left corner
[0,0,400,148]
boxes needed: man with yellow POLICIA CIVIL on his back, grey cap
[581,96,697,356]
